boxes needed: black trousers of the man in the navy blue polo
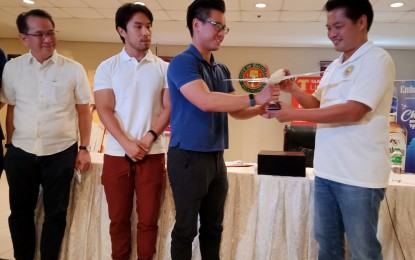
[167,147,228,260]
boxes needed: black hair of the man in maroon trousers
[115,3,153,43]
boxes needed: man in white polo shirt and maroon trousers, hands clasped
[94,4,170,259]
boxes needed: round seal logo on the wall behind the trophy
[239,63,268,93]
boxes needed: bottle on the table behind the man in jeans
[389,104,408,171]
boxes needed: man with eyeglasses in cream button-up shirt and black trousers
[1,9,91,259]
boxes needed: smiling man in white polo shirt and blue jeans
[274,0,395,260]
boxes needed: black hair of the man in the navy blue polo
[186,0,226,37]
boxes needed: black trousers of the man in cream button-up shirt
[4,143,78,260]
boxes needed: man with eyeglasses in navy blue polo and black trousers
[167,0,279,260]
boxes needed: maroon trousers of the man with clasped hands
[101,154,166,260]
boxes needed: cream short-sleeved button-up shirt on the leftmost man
[1,51,91,156]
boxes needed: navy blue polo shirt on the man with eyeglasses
[167,45,235,152]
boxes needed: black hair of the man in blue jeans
[324,0,373,31]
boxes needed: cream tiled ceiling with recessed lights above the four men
[0,0,415,49]
